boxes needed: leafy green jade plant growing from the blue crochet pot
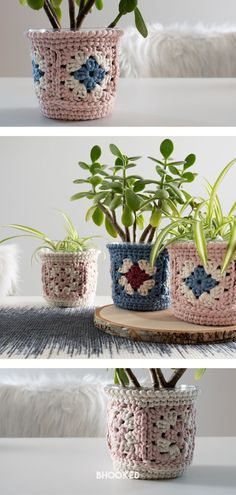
[71,139,197,243]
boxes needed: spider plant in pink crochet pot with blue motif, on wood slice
[151,160,236,326]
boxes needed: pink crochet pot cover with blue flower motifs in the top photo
[27,29,122,120]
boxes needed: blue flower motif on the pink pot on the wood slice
[184,265,219,299]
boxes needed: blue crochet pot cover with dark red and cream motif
[107,243,170,311]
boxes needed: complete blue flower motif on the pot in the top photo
[71,57,106,93]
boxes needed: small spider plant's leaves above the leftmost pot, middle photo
[0,212,96,256]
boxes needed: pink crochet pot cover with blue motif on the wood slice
[168,242,236,326]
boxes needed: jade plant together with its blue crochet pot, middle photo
[71,139,196,311]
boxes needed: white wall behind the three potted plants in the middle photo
[0,137,236,295]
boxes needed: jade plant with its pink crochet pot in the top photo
[19,0,148,120]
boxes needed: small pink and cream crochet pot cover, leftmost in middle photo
[41,249,99,308]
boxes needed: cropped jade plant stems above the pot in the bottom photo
[114,368,206,390]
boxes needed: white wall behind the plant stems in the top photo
[0,0,236,76]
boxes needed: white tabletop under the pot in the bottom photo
[0,438,236,495]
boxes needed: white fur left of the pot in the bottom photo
[0,373,106,437]
